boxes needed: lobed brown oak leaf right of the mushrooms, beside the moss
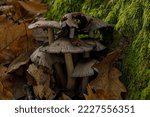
[90,50,126,99]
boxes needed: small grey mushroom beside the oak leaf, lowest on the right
[72,59,97,93]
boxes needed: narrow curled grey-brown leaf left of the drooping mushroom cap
[7,52,30,73]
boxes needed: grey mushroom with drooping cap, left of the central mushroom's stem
[30,46,66,88]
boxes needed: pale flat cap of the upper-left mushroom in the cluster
[28,20,61,29]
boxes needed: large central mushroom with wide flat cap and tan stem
[41,38,93,90]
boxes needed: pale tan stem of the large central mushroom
[65,53,75,90]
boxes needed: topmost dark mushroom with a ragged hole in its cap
[61,12,113,38]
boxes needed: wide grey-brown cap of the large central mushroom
[41,38,93,53]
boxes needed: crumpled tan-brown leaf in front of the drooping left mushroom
[27,64,55,99]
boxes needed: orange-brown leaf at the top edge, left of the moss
[18,1,48,14]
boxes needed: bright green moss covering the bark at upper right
[44,0,150,99]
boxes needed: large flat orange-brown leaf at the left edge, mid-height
[0,20,37,62]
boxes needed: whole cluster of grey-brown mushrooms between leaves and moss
[28,12,113,98]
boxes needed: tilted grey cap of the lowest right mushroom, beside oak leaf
[72,59,97,77]
